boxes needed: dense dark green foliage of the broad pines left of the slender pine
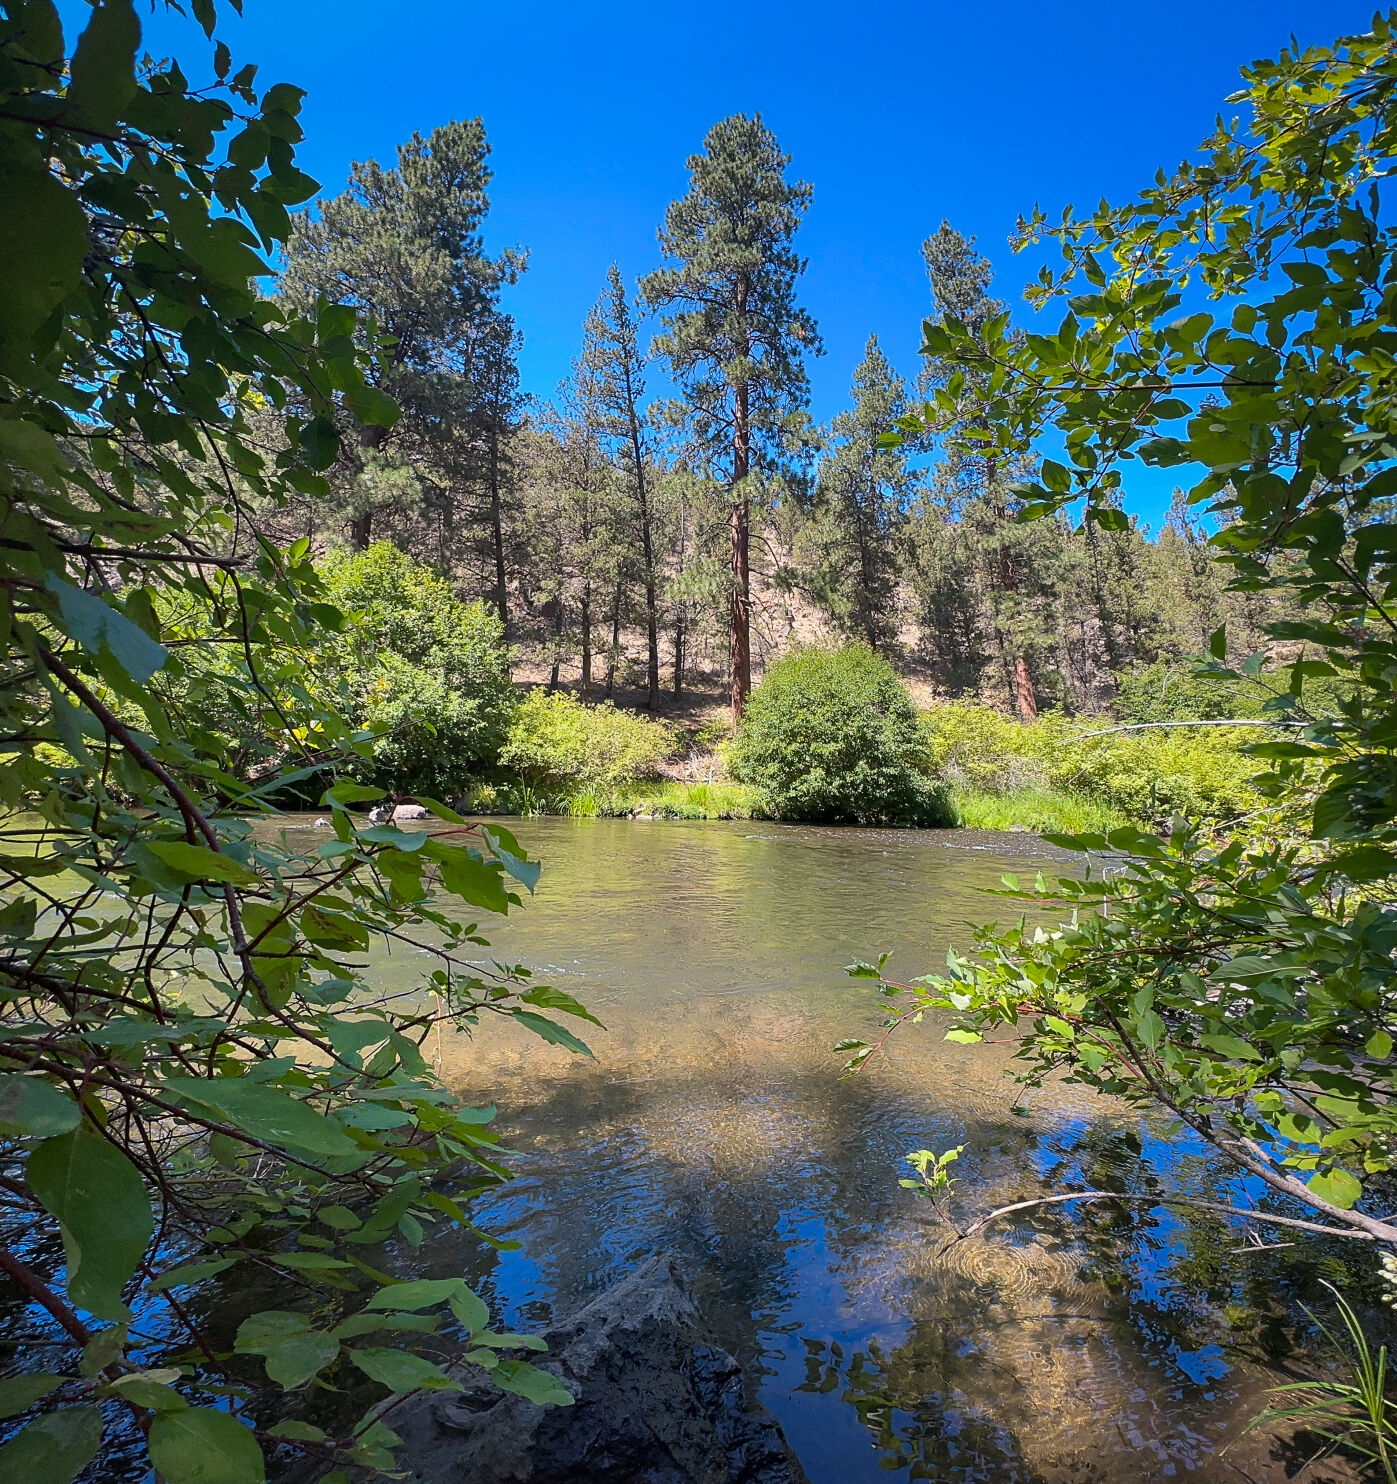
[279,119,524,563]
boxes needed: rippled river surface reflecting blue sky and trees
[286,819,1363,1484]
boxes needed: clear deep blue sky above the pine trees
[125,0,1372,518]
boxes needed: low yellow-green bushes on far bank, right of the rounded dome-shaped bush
[925,703,1262,828]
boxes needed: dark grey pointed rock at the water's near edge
[385,1257,806,1484]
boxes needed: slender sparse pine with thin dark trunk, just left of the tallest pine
[582,271,659,711]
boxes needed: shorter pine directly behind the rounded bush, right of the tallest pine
[800,335,917,650]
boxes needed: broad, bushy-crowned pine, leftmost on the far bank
[279,119,524,548]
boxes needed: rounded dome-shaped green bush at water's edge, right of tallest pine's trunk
[730,644,952,825]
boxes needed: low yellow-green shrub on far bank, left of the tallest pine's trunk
[500,690,675,791]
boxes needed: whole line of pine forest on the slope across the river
[258,116,1275,720]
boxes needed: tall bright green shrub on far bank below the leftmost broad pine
[324,542,515,797]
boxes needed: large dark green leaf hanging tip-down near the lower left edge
[25,1123,154,1321]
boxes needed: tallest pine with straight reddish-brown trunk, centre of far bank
[641,113,819,717]
